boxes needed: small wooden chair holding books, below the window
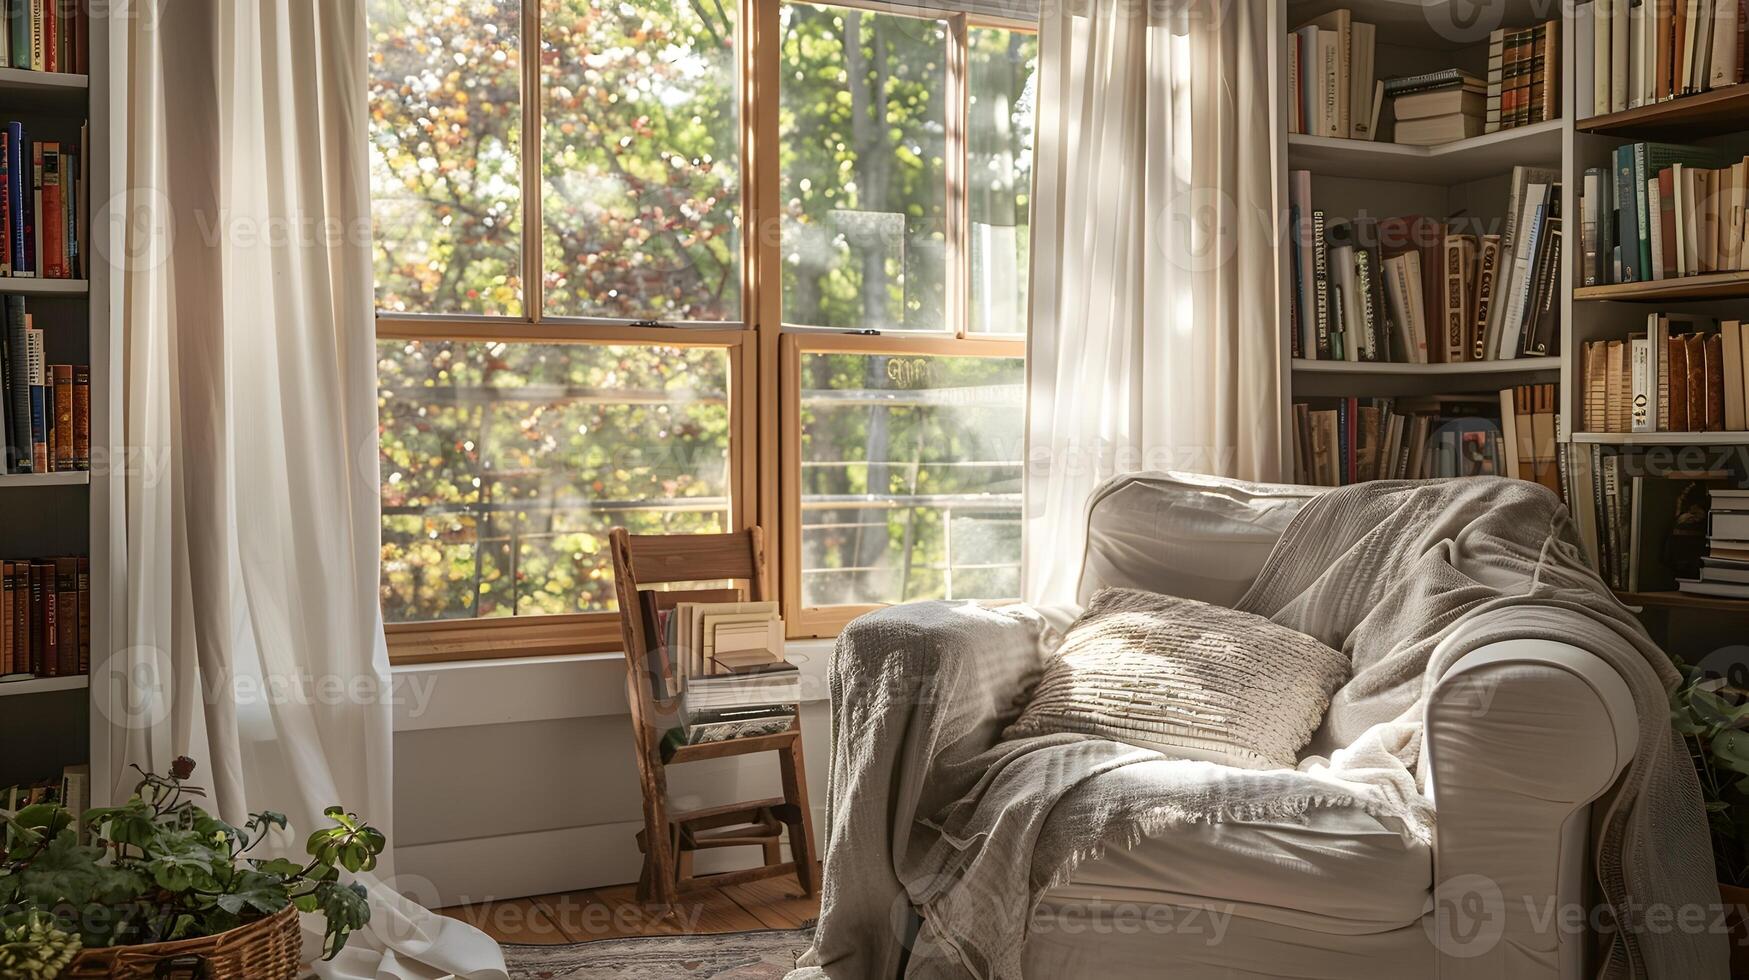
[609,527,813,905]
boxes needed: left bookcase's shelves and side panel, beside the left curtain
[0,13,126,805]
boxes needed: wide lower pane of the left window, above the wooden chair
[378,341,729,621]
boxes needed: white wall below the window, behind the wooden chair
[390,641,831,905]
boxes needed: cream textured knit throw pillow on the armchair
[1004,588,1348,768]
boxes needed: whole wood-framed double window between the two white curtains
[367,0,1035,662]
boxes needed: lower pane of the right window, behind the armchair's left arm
[801,354,1025,606]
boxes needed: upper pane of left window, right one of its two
[540,0,742,320]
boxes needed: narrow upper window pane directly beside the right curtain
[967,28,1039,334]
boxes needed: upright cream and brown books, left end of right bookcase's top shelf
[1287,9,1383,140]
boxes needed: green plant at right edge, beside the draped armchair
[1670,660,1749,977]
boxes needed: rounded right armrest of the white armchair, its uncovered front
[1424,639,1639,978]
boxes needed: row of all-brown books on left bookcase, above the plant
[0,557,91,681]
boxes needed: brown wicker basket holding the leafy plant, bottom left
[61,905,303,980]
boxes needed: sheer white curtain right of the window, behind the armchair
[1025,0,1287,604]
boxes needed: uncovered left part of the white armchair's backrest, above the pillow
[1077,473,1322,606]
